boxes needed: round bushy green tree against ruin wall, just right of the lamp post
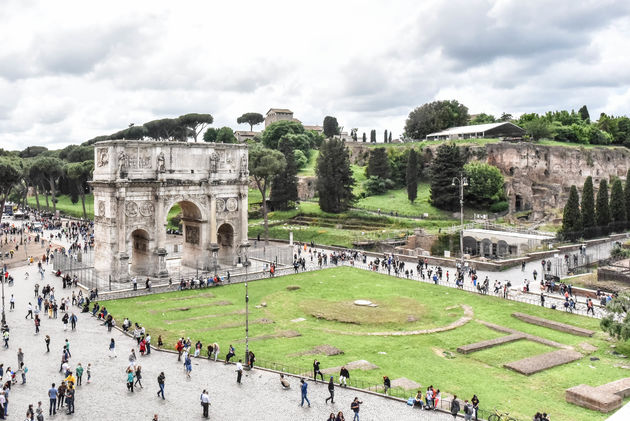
[464,161,505,207]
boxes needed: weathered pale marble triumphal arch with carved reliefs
[92,140,249,281]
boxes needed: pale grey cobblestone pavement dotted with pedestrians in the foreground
[0,260,452,421]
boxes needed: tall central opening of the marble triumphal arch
[165,201,209,276]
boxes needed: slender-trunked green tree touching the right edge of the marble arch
[249,145,287,244]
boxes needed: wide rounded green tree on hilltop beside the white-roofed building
[405,100,468,140]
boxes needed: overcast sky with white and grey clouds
[0,0,630,150]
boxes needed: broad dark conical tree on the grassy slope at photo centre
[316,138,355,213]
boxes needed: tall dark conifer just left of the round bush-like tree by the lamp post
[430,143,464,211]
